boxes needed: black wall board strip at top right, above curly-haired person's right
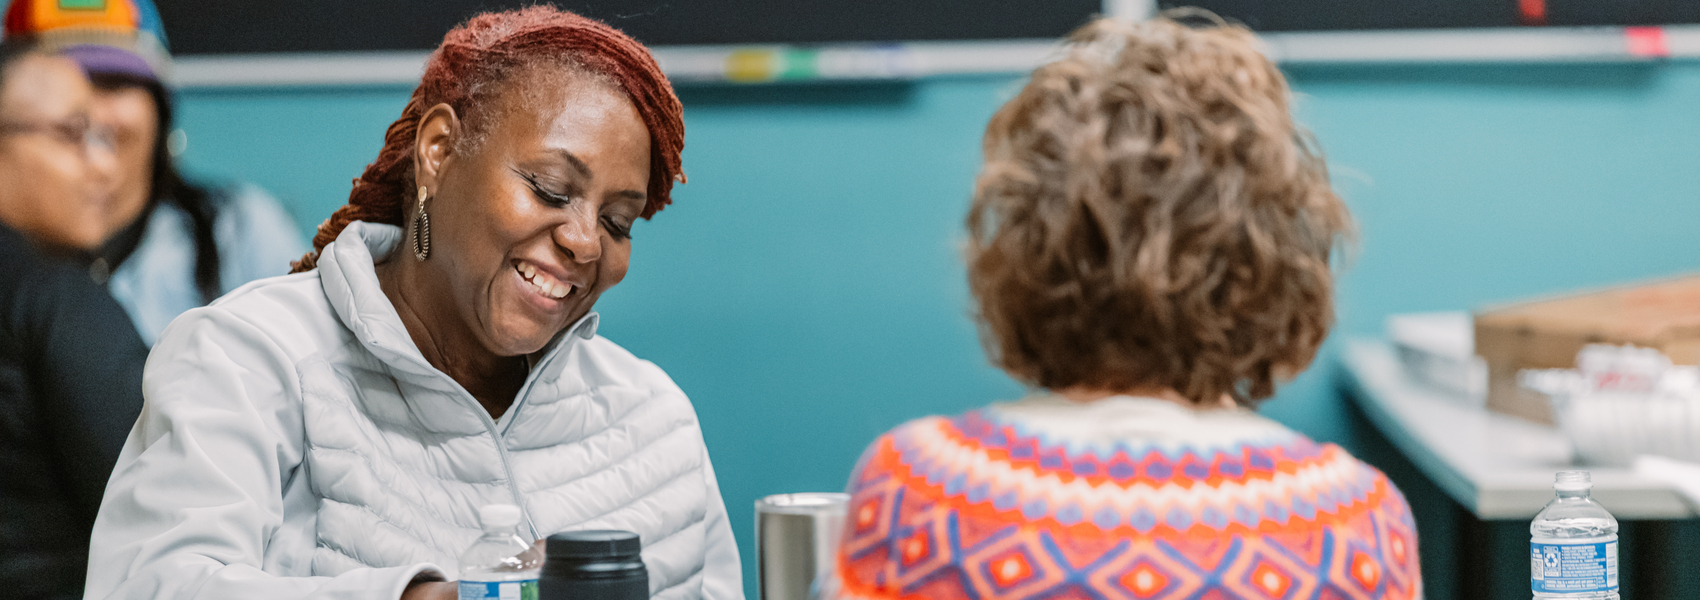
[1158,0,1700,31]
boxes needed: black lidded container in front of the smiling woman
[537,530,649,600]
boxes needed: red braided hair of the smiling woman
[292,5,685,272]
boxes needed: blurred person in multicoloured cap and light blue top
[5,0,306,345]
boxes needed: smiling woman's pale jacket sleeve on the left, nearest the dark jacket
[85,306,435,600]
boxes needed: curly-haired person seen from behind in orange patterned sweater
[833,19,1421,600]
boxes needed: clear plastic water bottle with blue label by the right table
[1528,471,1618,600]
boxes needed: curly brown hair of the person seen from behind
[967,17,1352,406]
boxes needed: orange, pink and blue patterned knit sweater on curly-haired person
[828,398,1421,600]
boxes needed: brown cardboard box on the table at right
[1476,275,1700,425]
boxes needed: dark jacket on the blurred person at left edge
[0,226,148,598]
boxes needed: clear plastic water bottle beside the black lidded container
[461,505,542,600]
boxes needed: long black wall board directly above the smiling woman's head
[158,0,1103,54]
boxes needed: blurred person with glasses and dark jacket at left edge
[0,39,148,598]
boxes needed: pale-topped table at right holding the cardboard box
[1341,338,1700,600]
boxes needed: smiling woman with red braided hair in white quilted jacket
[85,7,741,600]
